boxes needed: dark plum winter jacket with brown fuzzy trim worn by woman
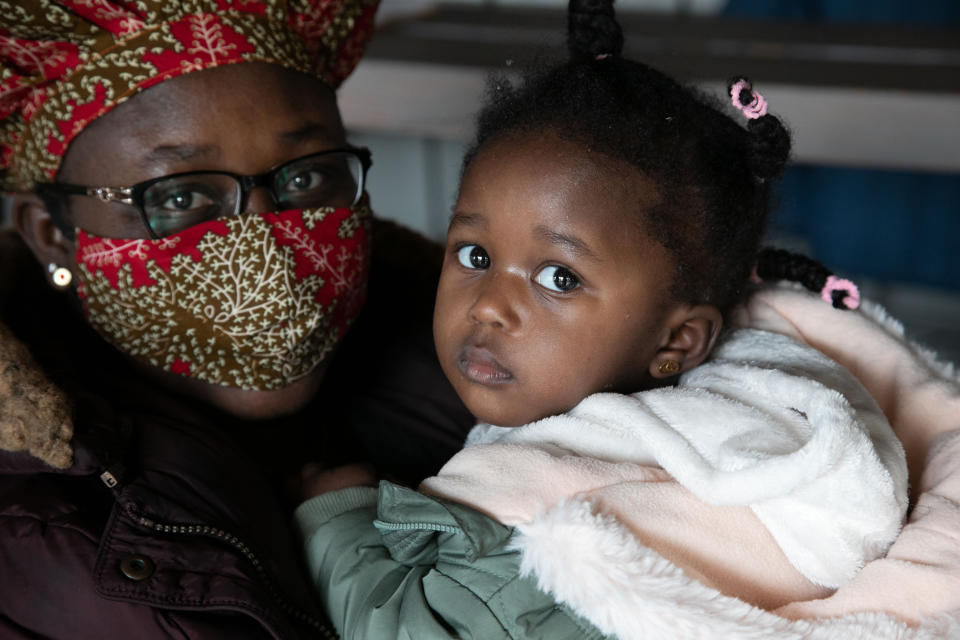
[0,224,472,639]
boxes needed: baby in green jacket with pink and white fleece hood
[297,0,906,638]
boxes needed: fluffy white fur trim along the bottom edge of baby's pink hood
[512,499,960,640]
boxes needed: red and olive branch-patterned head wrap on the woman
[0,0,379,190]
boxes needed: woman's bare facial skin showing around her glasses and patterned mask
[37,63,354,418]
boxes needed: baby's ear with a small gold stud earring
[650,304,723,379]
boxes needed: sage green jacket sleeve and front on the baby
[296,482,606,640]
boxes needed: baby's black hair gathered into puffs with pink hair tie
[464,0,840,314]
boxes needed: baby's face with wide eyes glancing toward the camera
[434,135,673,426]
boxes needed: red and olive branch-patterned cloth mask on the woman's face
[76,203,370,390]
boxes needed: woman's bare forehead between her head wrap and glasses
[58,63,345,184]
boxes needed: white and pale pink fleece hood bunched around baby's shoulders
[424,289,960,638]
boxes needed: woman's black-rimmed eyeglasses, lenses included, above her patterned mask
[37,149,372,238]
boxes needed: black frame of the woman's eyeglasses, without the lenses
[36,147,373,240]
